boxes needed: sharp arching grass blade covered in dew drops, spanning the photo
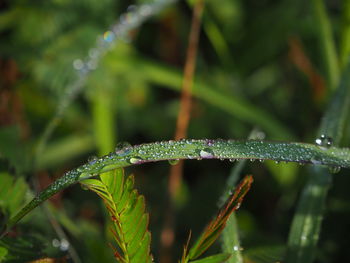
[1,139,350,236]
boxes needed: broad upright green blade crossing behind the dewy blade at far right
[286,64,350,263]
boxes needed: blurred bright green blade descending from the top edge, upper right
[312,0,340,90]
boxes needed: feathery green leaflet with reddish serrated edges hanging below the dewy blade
[82,169,152,262]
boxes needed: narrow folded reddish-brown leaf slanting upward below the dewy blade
[187,176,253,260]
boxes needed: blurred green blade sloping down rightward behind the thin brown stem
[106,52,295,140]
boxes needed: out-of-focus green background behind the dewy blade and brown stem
[0,0,350,262]
